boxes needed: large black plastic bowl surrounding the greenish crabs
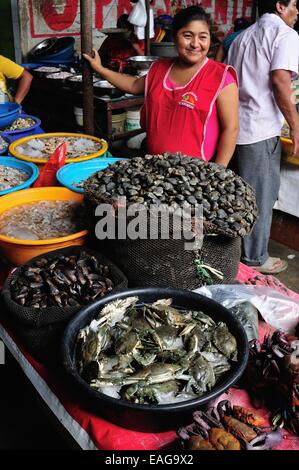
[62,287,248,432]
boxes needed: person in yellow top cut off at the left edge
[0,55,32,104]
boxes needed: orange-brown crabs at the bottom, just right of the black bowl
[177,400,282,450]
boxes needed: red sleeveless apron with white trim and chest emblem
[140,59,237,159]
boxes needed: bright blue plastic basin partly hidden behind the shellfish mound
[56,157,127,193]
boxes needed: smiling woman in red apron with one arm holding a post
[84,6,238,166]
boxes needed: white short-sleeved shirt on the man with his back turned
[227,13,299,145]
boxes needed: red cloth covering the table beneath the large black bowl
[0,264,299,451]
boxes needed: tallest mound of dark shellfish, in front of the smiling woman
[84,153,257,237]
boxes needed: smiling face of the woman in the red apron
[174,20,211,65]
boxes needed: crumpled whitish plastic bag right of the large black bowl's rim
[194,284,299,335]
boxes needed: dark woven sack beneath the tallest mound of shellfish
[86,201,241,290]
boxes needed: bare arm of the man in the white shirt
[271,69,299,155]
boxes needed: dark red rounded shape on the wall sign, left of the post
[41,0,79,31]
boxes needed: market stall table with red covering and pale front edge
[0,264,299,450]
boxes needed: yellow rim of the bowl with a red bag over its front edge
[9,132,108,165]
